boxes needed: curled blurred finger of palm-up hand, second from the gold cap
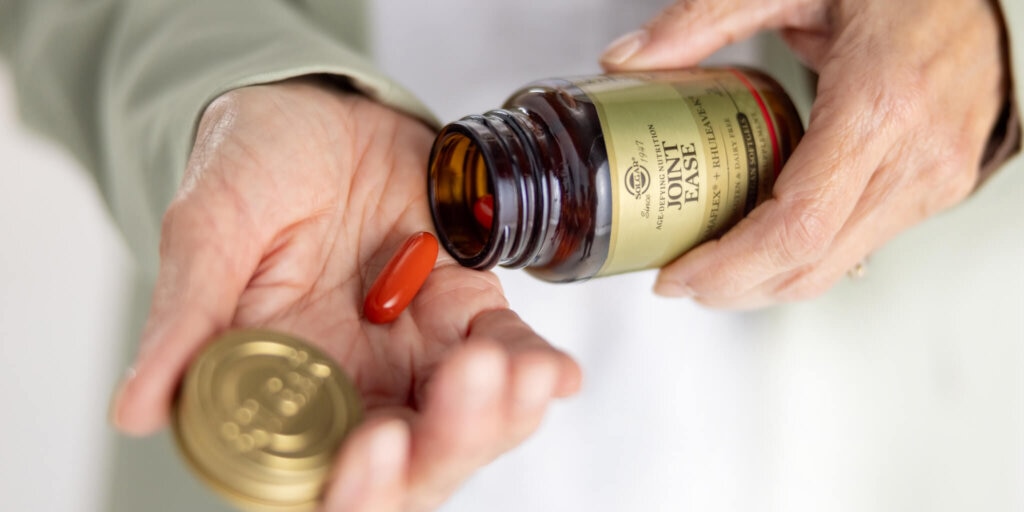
[410,342,510,510]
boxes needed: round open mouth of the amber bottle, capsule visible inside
[428,130,497,268]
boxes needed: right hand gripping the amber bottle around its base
[603,0,1007,307]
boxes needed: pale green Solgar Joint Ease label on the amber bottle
[573,69,781,275]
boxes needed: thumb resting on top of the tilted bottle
[601,0,823,71]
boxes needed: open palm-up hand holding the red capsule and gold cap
[112,79,581,512]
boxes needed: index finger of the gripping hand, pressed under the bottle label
[654,78,914,299]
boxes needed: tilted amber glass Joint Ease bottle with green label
[428,68,803,282]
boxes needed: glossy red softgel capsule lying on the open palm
[362,231,438,324]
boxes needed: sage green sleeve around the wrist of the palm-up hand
[0,0,434,269]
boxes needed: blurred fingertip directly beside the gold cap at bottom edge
[322,418,410,512]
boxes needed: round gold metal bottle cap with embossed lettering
[171,330,362,512]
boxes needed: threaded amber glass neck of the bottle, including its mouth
[428,110,551,269]
